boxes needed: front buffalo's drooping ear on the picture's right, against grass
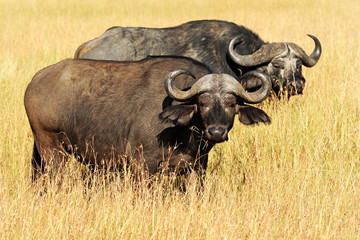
[239,105,271,125]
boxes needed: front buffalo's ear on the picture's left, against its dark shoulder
[159,105,197,125]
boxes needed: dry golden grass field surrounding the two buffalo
[0,0,360,239]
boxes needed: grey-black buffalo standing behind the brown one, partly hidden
[75,20,321,96]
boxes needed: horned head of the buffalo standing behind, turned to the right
[229,34,321,96]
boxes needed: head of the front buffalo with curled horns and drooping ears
[160,69,271,143]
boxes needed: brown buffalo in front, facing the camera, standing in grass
[24,57,271,180]
